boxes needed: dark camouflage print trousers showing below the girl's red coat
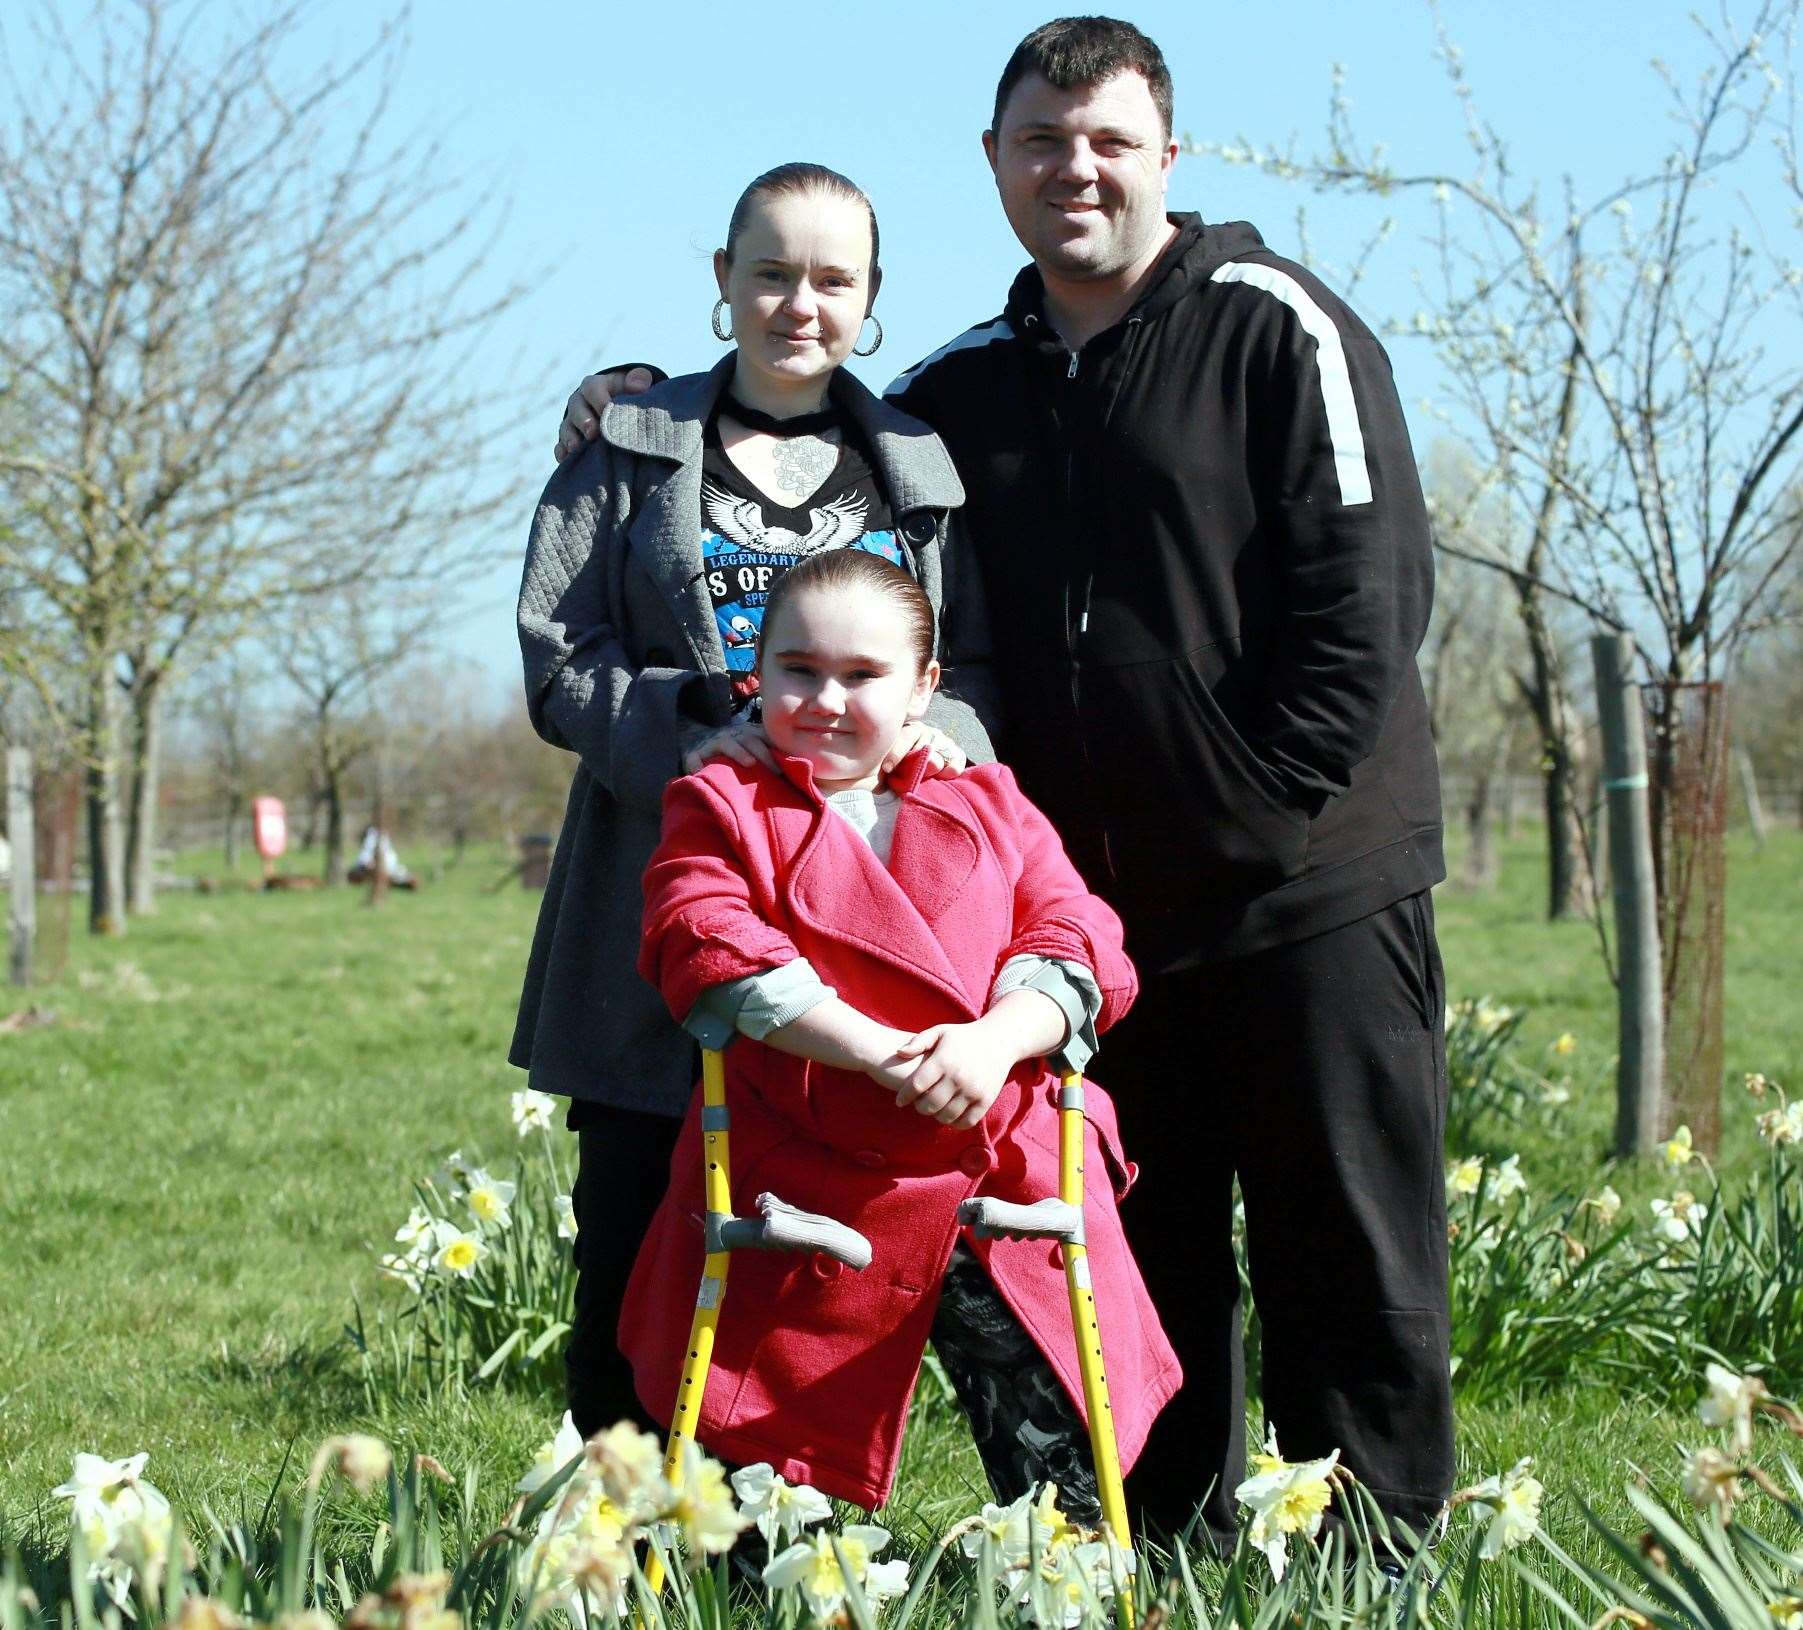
[932,1246,1102,1527]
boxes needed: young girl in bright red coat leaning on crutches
[620,550,1179,1524]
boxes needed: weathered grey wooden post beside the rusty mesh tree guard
[1590,635,1664,1156]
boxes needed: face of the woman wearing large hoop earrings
[714,191,876,395]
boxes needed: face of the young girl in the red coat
[757,588,939,792]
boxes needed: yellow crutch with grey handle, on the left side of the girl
[645,1048,871,1590]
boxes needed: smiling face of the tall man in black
[983,69,1177,283]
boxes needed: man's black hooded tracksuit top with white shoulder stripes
[891,215,1444,970]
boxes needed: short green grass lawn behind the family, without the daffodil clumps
[0,833,1803,1565]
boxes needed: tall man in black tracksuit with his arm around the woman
[561,18,1453,1538]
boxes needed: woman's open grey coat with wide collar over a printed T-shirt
[508,355,993,1116]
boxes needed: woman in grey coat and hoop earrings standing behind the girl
[510,164,992,1435]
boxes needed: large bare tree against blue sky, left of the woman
[0,0,530,930]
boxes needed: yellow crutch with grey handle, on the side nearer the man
[957,1071,1132,1621]
